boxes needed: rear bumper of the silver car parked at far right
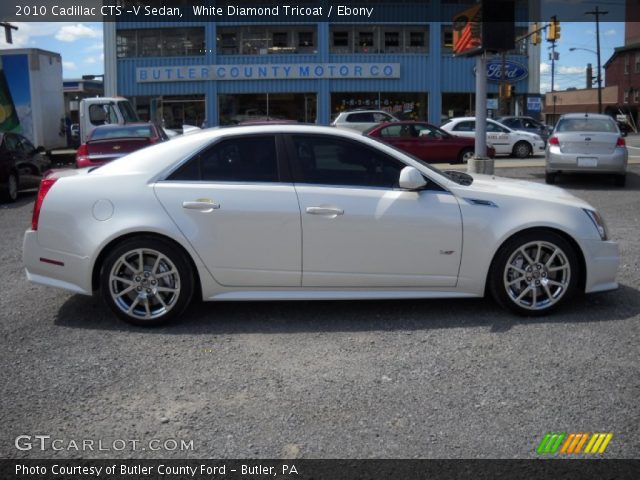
[545,147,628,174]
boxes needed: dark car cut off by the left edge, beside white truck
[0,133,51,202]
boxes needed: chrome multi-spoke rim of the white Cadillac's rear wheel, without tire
[109,248,180,320]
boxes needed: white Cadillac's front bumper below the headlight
[582,240,620,293]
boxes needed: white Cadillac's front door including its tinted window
[287,134,462,288]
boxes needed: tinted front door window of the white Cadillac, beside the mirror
[292,135,406,188]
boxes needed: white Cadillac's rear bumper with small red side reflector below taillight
[22,230,92,295]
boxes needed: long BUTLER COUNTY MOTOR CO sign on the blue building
[136,63,400,83]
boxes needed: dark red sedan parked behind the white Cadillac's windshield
[365,122,496,163]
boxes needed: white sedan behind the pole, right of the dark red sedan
[440,117,545,158]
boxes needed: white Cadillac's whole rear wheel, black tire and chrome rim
[100,236,195,326]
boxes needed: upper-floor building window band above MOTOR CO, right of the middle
[331,25,429,53]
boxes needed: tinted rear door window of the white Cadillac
[169,135,279,182]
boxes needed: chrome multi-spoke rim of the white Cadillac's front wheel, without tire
[503,241,571,310]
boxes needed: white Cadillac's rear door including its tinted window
[155,135,302,287]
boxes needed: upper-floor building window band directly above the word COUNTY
[216,25,316,55]
